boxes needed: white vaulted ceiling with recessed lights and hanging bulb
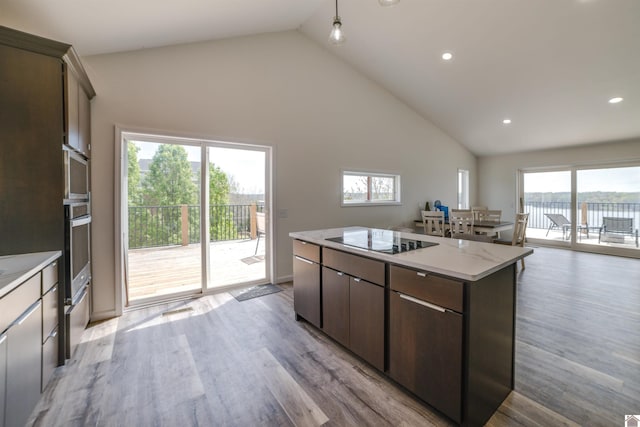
[0,0,640,155]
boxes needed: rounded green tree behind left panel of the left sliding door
[143,144,198,206]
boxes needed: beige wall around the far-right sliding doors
[477,140,640,229]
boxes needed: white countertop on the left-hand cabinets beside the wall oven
[0,251,62,298]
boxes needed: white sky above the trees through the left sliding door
[135,141,265,194]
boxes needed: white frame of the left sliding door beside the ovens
[114,125,275,316]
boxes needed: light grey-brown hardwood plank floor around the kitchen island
[30,248,640,426]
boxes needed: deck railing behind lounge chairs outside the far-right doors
[524,202,640,229]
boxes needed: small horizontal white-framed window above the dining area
[342,171,400,206]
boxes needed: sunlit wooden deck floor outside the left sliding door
[128,239,266,302]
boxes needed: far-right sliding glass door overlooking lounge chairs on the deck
[520,165,640,256]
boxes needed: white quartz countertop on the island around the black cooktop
[289,227,533,281]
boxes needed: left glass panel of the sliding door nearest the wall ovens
[126,140,202,303]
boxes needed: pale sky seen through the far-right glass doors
[524,166,640,193]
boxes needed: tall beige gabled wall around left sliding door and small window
[84,31,476,318]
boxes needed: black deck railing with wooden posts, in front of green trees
[129,204,264,249]
